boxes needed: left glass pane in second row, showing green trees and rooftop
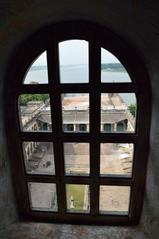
[19,94,52,131]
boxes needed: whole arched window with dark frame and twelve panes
[5,22,150,224]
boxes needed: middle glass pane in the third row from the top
[64,143,89,175]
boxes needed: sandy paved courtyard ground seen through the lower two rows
[25,143,132,212]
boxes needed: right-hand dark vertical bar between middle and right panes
[89,42,100,215]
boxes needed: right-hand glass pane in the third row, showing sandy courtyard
[100,143,134,176]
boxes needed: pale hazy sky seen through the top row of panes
[34,40,119,65]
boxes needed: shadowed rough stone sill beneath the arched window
[0,223,151,239]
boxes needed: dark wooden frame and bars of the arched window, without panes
[4,21,151,225]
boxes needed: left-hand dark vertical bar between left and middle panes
[48,42,66,214]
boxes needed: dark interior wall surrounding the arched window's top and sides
[0,0,159,238]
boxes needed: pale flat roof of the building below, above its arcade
[38,94,127,124]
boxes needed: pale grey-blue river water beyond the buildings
[24,65,136,105]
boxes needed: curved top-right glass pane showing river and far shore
[101,48,131,83]
